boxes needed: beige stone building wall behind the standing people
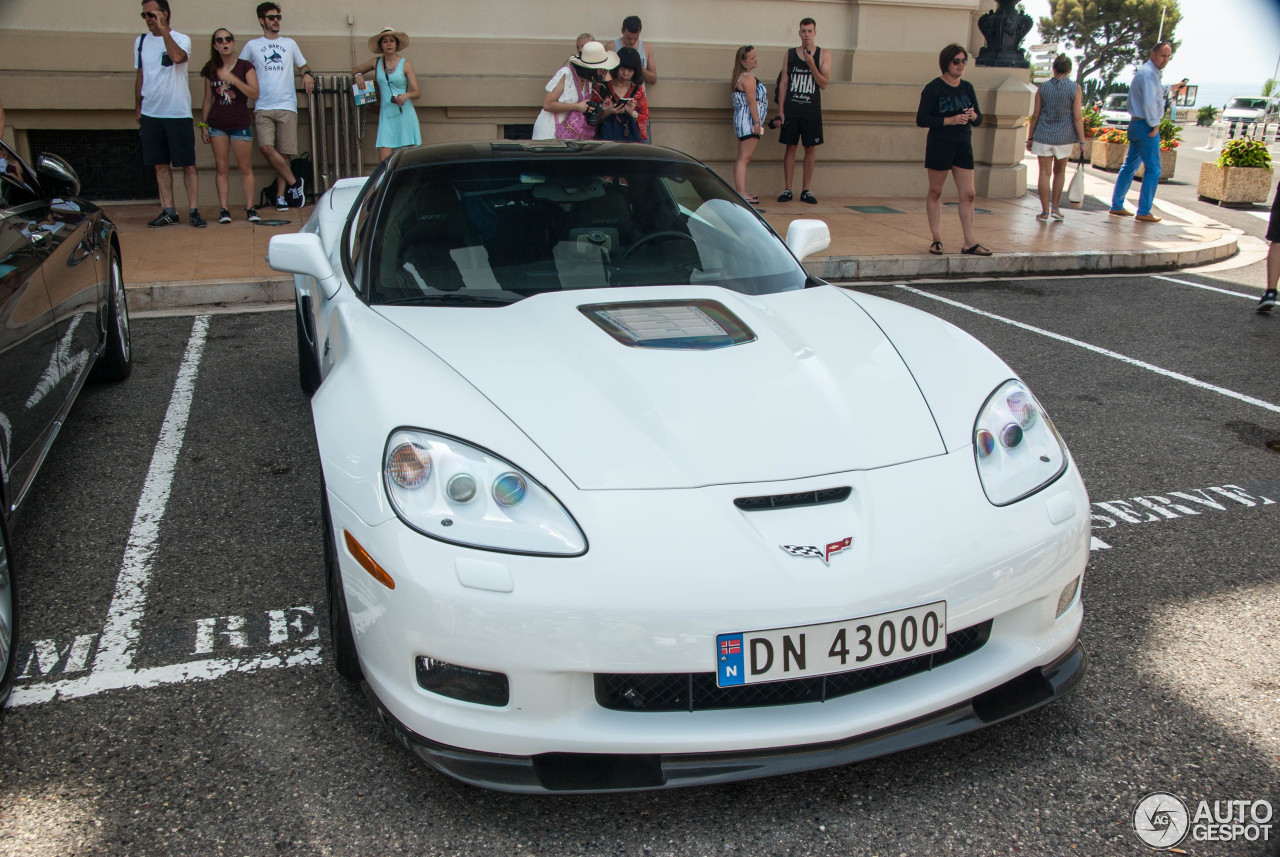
[0,0,1034,205]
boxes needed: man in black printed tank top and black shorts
[778,18,831,203]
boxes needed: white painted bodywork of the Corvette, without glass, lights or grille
[273,157,1089,790]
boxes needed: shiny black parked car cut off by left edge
[0,143,132,704]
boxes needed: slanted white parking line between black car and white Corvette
[93,316,209,673]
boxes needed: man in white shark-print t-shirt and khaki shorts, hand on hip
[241,3,315,211]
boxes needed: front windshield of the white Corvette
[367,157,806,306]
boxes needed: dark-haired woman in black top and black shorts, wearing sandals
[915,45,991,256]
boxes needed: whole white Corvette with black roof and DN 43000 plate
[269,142,1089,792]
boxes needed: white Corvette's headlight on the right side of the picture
[973,381,1066,505]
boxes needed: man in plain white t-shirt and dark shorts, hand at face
[133,0,205,226]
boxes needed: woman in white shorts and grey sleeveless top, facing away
[1027,54,1084,220]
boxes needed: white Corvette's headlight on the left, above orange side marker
[383,429,586,556]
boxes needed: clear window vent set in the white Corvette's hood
[579,301,755,350]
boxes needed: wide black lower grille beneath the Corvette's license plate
[595,619,991,711]
